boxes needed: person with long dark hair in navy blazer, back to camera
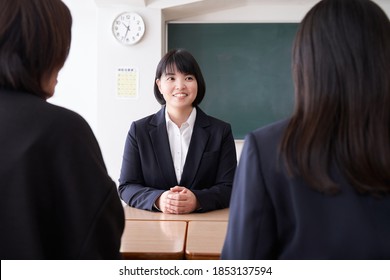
[221,0,390,259]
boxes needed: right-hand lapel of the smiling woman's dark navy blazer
[180,107,210,188]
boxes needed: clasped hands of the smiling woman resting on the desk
[156,186,199,214]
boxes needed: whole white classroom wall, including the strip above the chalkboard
[50,0,390,186]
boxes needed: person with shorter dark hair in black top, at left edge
[0,0,124,260]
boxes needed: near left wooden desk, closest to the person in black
[120,220,187,260]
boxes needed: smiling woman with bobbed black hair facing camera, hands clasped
[119,49,237,214]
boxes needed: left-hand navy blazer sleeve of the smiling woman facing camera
[118,122,165,210]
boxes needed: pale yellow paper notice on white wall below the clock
[117,67,139,99]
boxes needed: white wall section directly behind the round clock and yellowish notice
[97,6,162,182]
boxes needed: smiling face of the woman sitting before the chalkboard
[156,67,198,111]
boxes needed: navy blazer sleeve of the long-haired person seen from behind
[221,133,277,259]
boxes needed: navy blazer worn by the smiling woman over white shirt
[118,106,237,212]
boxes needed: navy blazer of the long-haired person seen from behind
[221,121,390,259]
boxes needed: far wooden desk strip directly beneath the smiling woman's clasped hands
[124,205,229,222]
